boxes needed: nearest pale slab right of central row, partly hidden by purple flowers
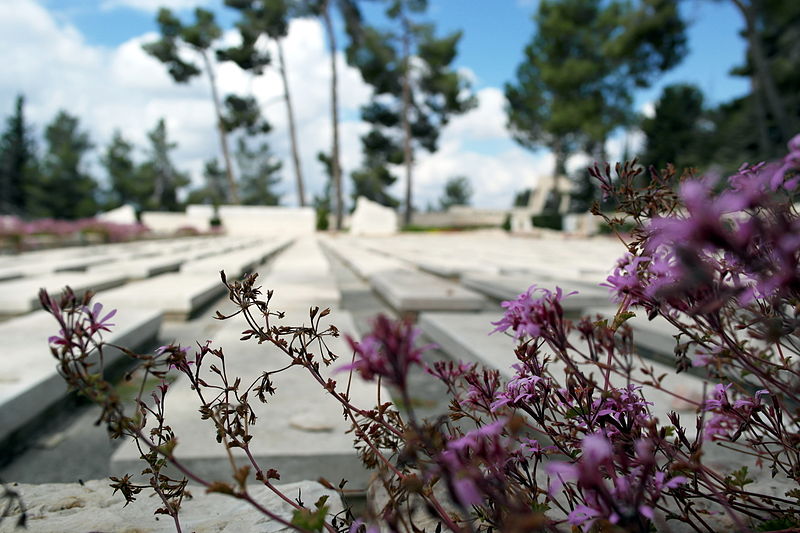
[419,313,711,435]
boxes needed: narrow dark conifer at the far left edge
[0,95,36,214]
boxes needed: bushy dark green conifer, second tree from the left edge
[26,111,97,219]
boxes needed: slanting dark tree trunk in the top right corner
[732,0,792,143]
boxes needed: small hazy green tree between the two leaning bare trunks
[235,137,283,205]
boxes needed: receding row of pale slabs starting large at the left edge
[0,235,296,442]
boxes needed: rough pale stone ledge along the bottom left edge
[0,477,343,533]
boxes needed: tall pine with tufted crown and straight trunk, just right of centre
[347,0,476,224]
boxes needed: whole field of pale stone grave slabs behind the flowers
[0,231,788,531]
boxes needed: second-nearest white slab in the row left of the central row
[100,273,227,319]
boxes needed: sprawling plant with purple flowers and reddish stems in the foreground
[29,137,800,533]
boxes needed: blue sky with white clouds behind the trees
[0,0,747,208]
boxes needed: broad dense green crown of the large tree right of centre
[505,0,686,171]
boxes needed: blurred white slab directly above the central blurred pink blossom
[370,270,486,313]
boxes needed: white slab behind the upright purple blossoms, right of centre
[461,274,610,312]
